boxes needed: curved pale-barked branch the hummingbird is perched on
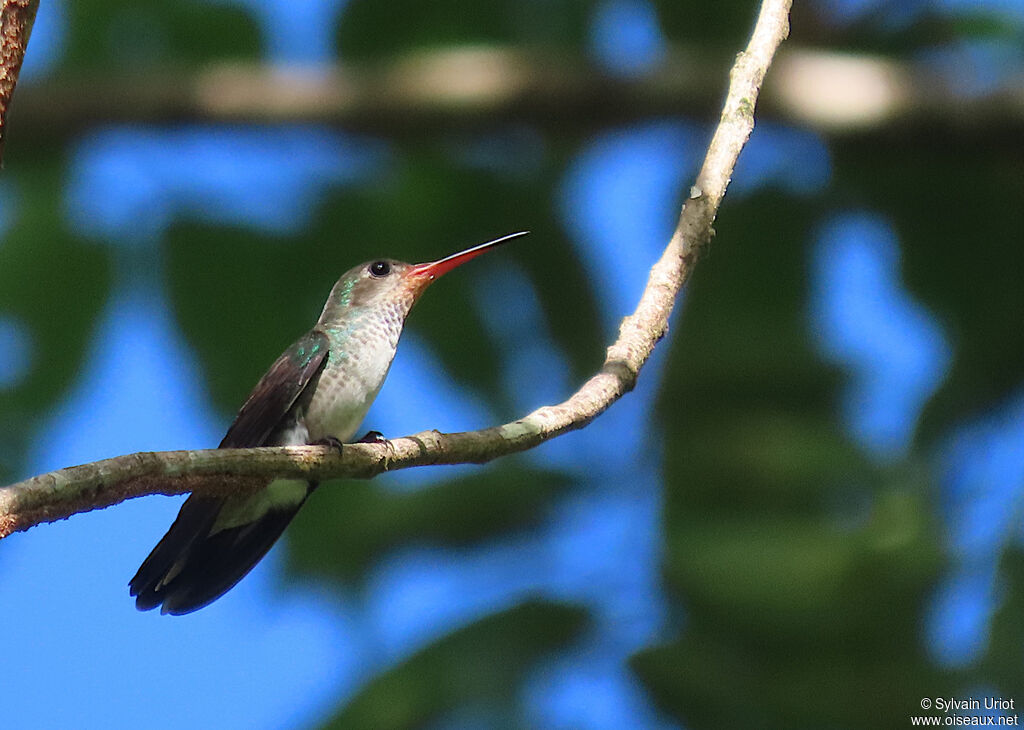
[0,0,792,538]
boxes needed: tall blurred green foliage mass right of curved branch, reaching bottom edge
[633,192,951,728]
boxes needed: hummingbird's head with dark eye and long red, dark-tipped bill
[321,231,527,321]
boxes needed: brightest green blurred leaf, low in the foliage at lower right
[666,492,941,642]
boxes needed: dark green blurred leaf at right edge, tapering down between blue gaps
[836,137,1024,443]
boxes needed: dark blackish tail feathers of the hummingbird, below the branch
[129,485,312,615]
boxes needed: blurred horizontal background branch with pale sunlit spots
[12,45,1024,144]
